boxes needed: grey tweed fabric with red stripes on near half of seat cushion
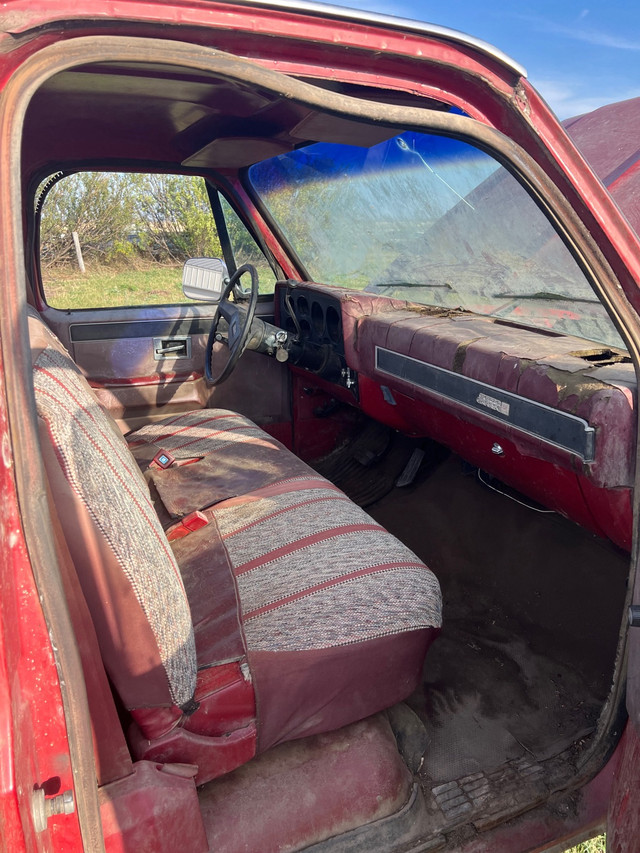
[213,483,442,651]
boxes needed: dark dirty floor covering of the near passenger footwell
[369,457,628,785]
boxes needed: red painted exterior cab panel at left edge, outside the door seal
[0,360,81,853]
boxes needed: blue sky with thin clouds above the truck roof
[327,0,640,119]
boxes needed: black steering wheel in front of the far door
[204,264,258,385]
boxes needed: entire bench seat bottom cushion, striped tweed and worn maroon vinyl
[129,416,441,751]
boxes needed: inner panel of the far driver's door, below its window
[43,302,291,432]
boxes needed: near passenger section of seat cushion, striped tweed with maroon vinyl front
[208,471,441,751]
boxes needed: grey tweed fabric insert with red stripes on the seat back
[34,347,196,705]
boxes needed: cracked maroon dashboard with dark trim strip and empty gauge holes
[277,282,637,549]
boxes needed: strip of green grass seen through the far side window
[43,264,187,309]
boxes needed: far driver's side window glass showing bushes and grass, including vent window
[40,172,274,310]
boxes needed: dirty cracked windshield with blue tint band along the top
[249,132,623,347]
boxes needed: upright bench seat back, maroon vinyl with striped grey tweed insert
[29,314,197,708]
